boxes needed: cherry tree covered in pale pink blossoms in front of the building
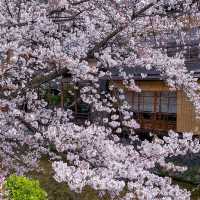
[0,0,200,200]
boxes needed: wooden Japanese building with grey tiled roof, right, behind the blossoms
[110,28,200,135]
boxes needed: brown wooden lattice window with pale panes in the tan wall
[126,91,177,130]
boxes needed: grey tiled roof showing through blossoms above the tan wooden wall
[111,27,200,80]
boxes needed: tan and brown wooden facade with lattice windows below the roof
[113,80,200,135]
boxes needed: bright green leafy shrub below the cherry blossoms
[5,175,47,200]
